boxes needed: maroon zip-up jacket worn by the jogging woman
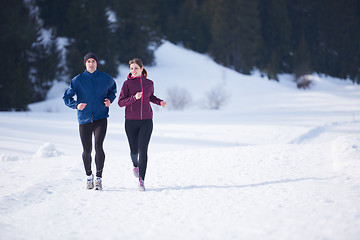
[118,73,162,120]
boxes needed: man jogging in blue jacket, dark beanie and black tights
[63,52,116,190]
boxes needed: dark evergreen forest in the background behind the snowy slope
[0,0,360,111]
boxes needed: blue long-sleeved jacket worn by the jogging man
[63,70,116,124]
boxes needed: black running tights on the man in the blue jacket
[79,118,107,177]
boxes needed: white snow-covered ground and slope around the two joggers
[0,42,360,240]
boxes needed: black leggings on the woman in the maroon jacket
[125,119,153,180]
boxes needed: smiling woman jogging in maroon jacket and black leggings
[118,58,166,191]
